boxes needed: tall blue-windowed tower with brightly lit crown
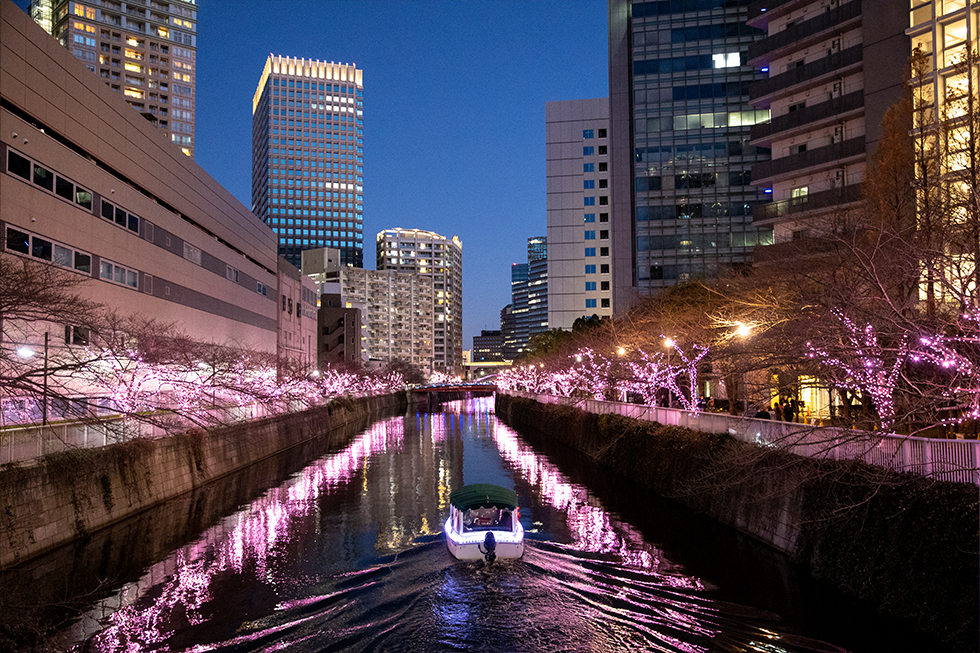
[252,55,364,268]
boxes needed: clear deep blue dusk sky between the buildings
[196,0,609,349]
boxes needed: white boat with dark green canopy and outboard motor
[445,483,524,563]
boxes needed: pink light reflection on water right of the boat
[494,423,688,586]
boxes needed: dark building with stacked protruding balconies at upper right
[748,0,910,246]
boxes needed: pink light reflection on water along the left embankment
[76,417,405,653]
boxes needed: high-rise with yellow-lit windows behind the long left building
[30,0,197,157]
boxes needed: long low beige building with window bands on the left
[0,0,279,408]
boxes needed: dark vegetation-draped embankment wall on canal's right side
[496,393,980,650]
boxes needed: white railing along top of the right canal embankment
[506,390,980,485]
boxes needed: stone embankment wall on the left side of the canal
[0,393,409,569]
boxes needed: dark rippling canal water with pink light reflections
[0,398,939,653]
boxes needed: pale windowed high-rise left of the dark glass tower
[545,98,612,330]
